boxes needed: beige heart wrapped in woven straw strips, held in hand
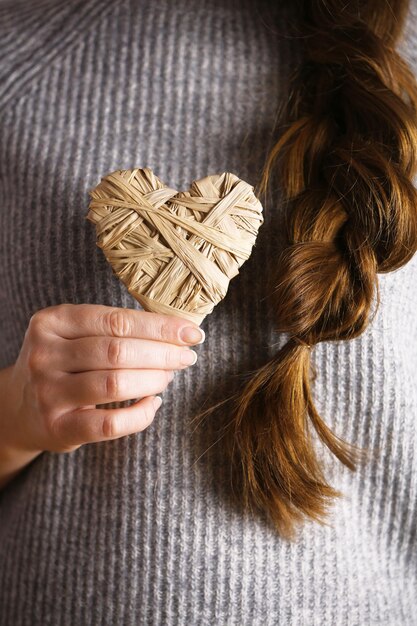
[86,167,263,324]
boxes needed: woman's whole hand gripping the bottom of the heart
[2,303,204,455]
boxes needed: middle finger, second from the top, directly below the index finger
[57,337,197,372]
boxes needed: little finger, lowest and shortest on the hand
[54,396,162,449]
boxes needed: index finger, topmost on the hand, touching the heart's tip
[37,302,204,346]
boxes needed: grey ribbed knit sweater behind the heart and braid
[0,0,417,626]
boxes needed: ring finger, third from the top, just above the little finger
[57,369,174,409]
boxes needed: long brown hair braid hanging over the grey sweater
[193,0,417,539]
